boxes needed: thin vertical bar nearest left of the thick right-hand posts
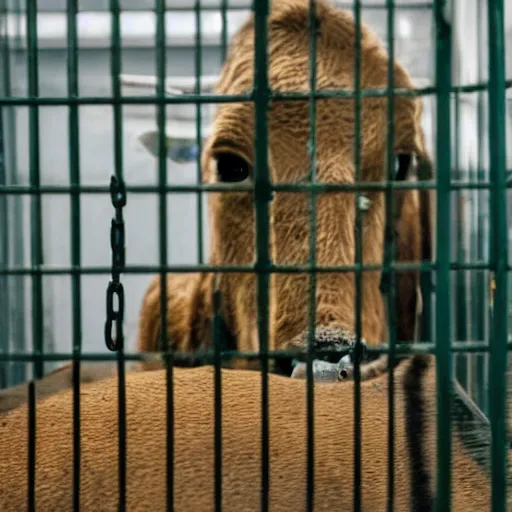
[382,0,396,512]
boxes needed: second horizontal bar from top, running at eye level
[0,180,506,196]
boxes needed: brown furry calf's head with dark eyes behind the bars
[202,0,424,364]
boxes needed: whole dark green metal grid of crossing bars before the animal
[2,0,508,510]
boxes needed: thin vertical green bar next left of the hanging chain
[67,0,82,511]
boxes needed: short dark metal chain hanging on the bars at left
[105,176,126,352]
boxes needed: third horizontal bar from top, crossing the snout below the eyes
[0,262,492,276]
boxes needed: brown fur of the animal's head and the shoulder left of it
[138,0,429,372]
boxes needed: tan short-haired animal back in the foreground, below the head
[0,356,504,512]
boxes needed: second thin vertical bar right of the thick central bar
[354,0,363,512]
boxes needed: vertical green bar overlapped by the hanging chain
[110,0,126,512]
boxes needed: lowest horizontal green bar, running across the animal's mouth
[0,342,512,362]
